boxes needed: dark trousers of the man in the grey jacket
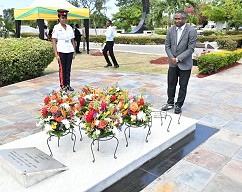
[167,66,191,107]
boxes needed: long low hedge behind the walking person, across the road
[90,36,165,45]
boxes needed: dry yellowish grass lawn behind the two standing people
[45,50,198,74]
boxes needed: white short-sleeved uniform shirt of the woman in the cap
[52,23,74,53]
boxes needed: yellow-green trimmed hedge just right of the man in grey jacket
[197,51,242,74]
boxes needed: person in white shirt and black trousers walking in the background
[103,20,119,68]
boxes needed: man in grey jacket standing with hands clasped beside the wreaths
[161,11,197,114]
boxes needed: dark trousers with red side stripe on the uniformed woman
[59,53,73,88]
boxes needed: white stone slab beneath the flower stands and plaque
[0,113,197,192]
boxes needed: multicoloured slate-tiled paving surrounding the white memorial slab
[0,46,242,192]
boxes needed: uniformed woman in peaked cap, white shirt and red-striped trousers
[52,9,76,91]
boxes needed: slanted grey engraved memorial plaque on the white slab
[0,147,67,187]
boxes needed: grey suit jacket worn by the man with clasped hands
[165,24,197,70]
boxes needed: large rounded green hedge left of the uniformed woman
[0,38,54,84]
